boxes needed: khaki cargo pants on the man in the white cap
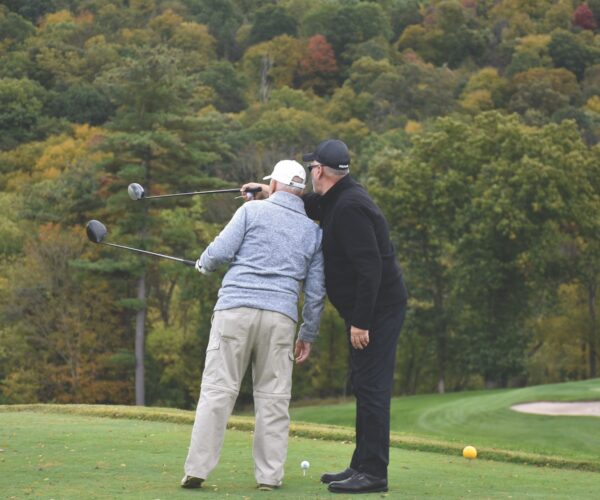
[185,307,296,485]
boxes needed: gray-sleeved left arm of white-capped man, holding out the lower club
[200,205,247,272]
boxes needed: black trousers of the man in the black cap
[346,304,406,478]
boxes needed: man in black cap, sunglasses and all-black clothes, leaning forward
[242,139,407,493]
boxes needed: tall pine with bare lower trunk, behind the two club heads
[96,48,241,404]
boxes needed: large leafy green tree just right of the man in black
[371,112,589,389]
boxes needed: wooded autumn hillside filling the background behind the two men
[0,0,600,408]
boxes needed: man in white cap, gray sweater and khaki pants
[181,160,325,490]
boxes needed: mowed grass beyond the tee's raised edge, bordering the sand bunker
[291,379,600,466]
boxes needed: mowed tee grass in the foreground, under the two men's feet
[0,407,600,499]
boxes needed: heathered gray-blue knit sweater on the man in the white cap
[200,191,325,342]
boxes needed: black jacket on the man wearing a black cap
[304,175,407,330]
